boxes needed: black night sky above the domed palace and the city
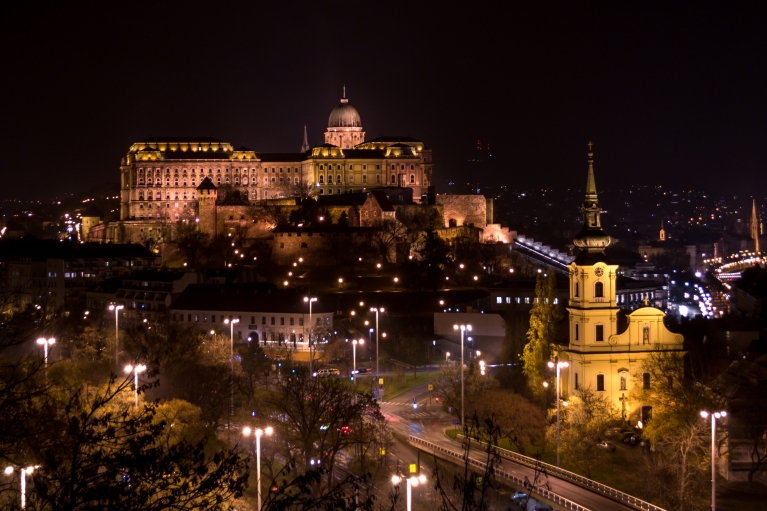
[0,1,767,202]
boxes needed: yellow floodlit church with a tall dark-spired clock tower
[560,143,684,425]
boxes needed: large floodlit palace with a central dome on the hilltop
[87,88,433,243]
